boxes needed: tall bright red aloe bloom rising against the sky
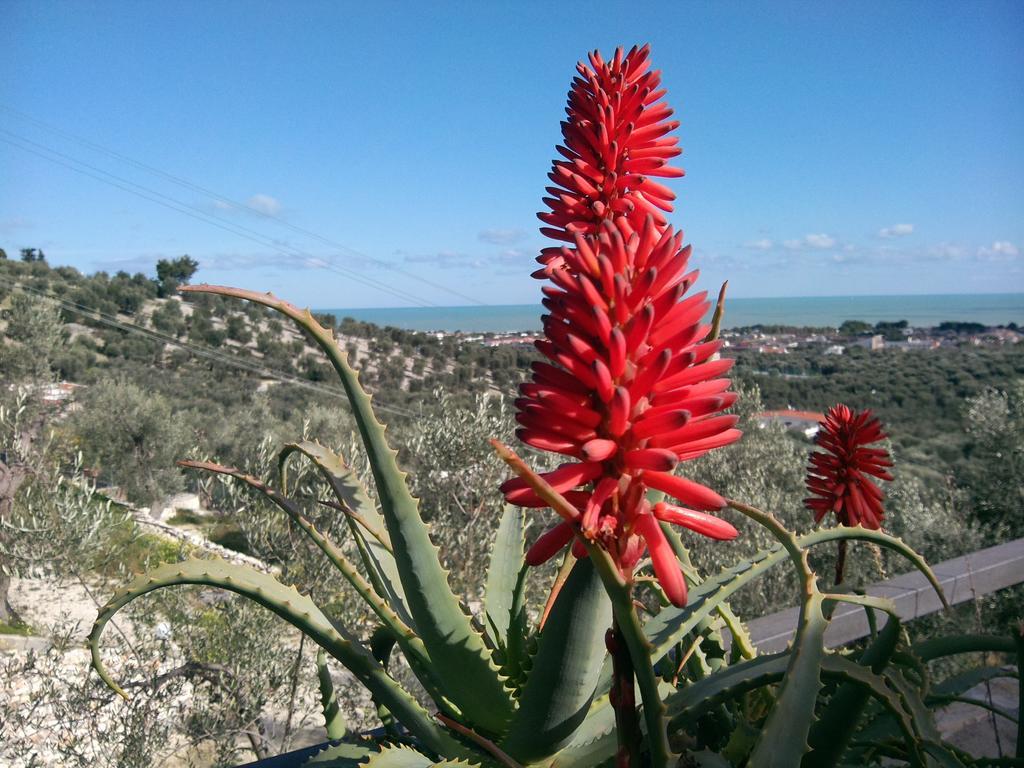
[502,46,741,605]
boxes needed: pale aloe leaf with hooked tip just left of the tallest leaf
[278,440,416,630]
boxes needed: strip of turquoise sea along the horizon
[315,293,1024,333]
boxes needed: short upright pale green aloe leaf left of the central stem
[483,504,526,648]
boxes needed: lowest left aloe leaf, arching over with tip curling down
[89,560,465,757]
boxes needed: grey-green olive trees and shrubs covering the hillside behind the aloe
[0,259,1024,767]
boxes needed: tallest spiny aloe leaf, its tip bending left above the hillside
[182,285,514,733]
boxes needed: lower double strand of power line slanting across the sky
[0,128,437,306]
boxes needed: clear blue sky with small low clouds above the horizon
[0,0,1024,307]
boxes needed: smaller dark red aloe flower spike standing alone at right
[804,404,893,530]
